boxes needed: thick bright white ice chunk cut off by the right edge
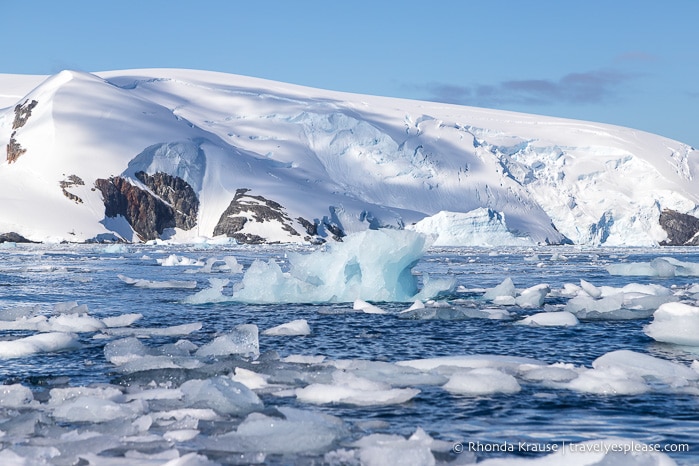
[643,303,699,346]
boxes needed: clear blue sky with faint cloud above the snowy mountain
[5,0,699,147]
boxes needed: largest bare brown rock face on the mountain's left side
[95,172,199,241]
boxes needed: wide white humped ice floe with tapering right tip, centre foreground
[296,371,420,406]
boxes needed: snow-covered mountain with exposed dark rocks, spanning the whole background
[0,69,699,245]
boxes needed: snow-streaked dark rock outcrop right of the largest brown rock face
[214,188,300,244]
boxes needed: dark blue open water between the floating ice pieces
[0,245,699,464]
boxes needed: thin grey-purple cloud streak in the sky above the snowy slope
[425,70,637,107]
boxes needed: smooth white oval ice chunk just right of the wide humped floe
[443,367,522,396]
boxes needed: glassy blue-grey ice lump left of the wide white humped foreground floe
[180,376,264,416]
